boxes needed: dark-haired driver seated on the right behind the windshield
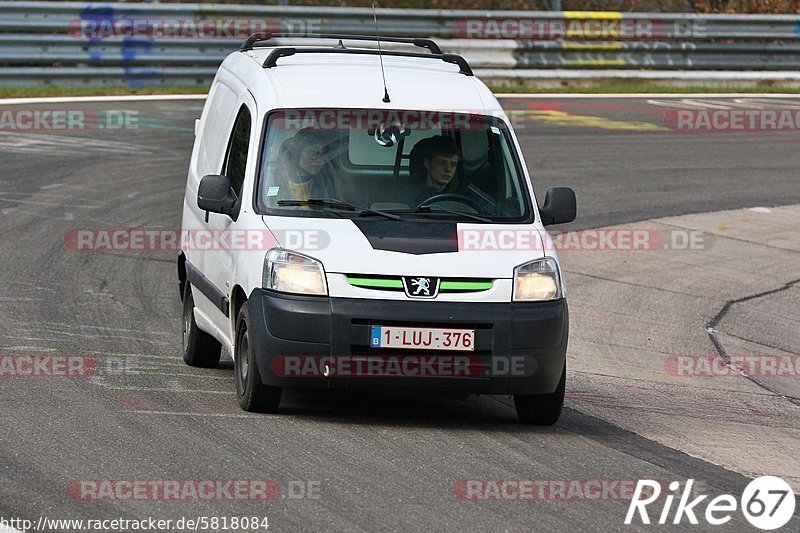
[398,135,461,207]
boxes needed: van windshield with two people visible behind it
[258,109,532,222]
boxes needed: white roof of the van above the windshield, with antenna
[238,47,499,114]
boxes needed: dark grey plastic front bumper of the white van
[246,289,569,395]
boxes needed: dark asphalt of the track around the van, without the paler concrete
[0,99,800,531]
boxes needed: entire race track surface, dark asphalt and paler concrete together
[0,98,800,531]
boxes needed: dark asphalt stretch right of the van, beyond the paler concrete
[503,94,800,227]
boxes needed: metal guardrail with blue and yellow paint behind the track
[0,1,800,86]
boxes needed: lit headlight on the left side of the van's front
[263,250,328,296]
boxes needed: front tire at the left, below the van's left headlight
[233,304,282,413]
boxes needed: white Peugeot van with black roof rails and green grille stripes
[178,34,576,424]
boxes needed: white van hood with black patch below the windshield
[262,215,547,279]
